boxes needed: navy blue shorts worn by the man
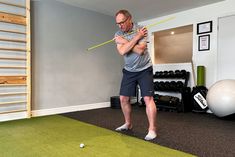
[120,66,154,97]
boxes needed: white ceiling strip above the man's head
[58,0,224,22]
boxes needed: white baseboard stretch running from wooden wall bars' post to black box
[32,102,110,117]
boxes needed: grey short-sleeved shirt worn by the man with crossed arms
[115,24,152,72]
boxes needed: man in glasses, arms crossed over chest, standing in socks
[114,10,157,140]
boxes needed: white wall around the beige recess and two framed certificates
[140,0,235,87]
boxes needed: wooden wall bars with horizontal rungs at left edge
[0,0,31,118]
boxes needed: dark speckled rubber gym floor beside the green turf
[63,106,235,157]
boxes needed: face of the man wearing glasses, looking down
[116,14,131,32]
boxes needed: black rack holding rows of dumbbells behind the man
[151,70,192,112]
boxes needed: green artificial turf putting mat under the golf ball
[0,115,193,157]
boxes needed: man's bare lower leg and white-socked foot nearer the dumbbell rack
[144,96,157,140]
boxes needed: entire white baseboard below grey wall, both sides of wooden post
[0,102,110,122]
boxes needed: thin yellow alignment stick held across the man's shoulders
[87,17,175,51]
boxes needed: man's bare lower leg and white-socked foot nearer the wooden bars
[116,95,132,131]
